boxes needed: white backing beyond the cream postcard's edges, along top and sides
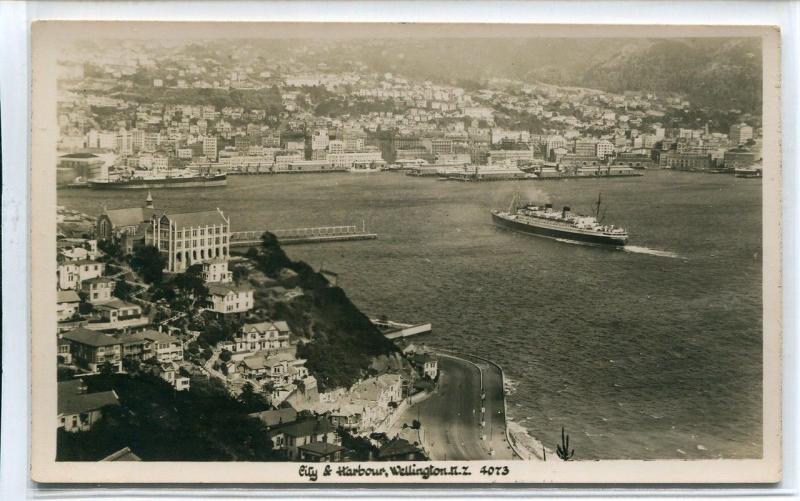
[0,2,798,492]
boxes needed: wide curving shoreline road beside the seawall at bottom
[400,355,514,461]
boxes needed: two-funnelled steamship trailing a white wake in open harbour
[492,191,628,247]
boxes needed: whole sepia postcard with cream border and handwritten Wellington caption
[31,22,781,483]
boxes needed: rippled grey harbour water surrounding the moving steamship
[58,171,762,459]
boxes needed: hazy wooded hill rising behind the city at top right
[330,38,762,114]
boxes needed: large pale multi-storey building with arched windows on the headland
[145,209,230,273]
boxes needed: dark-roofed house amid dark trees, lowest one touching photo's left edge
[57,379,119,433]
